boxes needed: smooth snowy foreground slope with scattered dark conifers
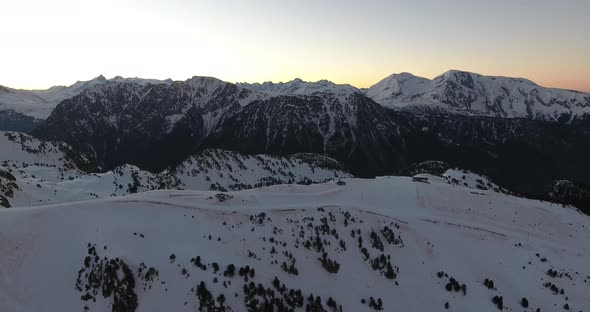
[0,176,590,311]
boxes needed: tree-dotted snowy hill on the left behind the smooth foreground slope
[0,132,352,207]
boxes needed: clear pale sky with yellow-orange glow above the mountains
[0,0,590,92]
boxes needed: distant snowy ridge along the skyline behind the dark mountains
[0,70,590,126]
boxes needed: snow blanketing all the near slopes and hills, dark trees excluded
[0,132,590,311]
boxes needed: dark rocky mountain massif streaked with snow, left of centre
[34,77,408,177]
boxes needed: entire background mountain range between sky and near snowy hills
[0,71,590,201]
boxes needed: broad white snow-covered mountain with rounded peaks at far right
[366,70,590,122]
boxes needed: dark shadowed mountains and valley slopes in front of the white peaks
[33,74,590,194]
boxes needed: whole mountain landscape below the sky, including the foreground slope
[0,71,590,312]
